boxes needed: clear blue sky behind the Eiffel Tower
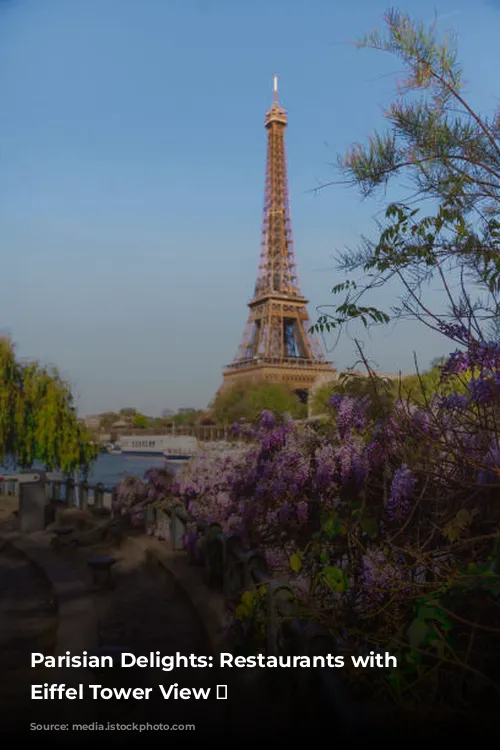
[0,0,500,414]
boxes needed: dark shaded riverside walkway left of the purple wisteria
[0,496,286,732]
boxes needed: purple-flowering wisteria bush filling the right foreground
[115,340,500,724]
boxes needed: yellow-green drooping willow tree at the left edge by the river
[0,339,97,473]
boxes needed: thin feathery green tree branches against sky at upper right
[316,10,500,344]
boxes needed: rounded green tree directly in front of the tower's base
[212,379,307,424]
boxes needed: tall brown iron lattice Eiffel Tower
[222,75,335,401]
